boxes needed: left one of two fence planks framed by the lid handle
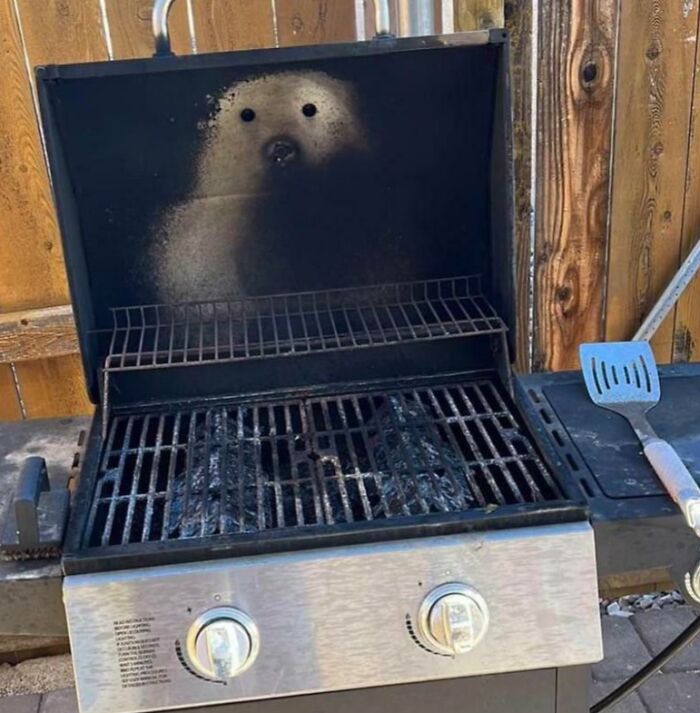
[192,0,278,52]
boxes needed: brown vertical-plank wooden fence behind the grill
[0,0,700,419]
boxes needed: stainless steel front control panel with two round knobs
[64,523,602,713]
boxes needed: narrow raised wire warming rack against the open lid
[105,276,505,371]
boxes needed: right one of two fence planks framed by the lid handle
[276,0,356,46]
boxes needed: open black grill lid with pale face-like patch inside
[38,30,514,400]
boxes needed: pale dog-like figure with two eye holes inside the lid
[153,71,366,303]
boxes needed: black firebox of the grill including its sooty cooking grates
[64,372,586,574]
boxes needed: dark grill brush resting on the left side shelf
[0,456,69,560]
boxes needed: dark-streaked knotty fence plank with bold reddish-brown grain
[534,0,616,370]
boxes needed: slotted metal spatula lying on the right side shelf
[579,342,700,537]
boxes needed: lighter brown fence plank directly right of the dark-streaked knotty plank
[606,0,698,362]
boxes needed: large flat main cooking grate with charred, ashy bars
[85,380,561,547]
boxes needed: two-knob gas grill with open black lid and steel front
[27,8,616,713]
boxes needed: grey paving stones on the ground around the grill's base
[0,607,700,713]
